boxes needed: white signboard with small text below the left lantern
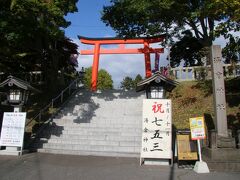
[0,112,26,147]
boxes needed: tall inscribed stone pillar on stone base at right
[203,45,240,171]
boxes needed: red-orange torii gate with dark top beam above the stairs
[78,35,165,91]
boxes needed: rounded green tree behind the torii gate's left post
[83,67,113,90]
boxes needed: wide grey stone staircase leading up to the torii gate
[37,90,144,157]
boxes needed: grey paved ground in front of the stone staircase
[0,153,240,180]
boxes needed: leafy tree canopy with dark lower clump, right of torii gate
[102,0,240,66]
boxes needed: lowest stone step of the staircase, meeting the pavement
[38,149,140,157]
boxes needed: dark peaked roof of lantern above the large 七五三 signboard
[136,71,179,92]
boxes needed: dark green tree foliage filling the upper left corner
[0,0,77,87]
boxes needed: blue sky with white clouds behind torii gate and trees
[65,0,232,88]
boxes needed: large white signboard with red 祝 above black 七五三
[141,99,172,159]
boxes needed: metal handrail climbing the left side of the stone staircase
[26,78,80,125]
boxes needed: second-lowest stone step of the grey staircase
[43,143,140,153]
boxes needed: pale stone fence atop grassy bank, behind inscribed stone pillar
[170,63,240,81]
